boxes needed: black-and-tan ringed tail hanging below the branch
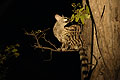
[79,49,88,80]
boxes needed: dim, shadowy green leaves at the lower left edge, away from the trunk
[0,44,20,80]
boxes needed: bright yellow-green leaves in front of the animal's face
[70,3,90,24]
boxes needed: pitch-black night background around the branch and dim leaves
[0,0,80,80]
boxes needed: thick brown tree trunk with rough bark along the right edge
[86,0,120,80]
